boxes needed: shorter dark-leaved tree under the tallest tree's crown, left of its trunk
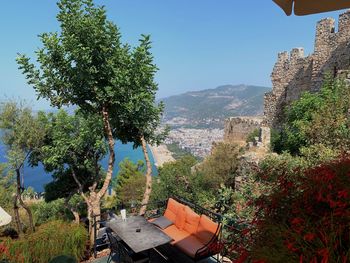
[31,110,107,238]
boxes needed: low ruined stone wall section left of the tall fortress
[224,117,263,145]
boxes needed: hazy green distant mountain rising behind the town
[162,85,271,128]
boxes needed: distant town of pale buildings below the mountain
[165,128,224,158]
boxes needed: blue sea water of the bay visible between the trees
[0,141,157,192]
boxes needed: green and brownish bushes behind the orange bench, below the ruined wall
[152,143,243,210]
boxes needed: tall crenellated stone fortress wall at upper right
[263,11,350,128]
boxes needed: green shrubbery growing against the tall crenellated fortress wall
[272,76,350,155]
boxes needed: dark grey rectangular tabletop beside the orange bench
[106,216,172,253]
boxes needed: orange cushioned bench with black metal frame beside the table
[157,198,221,260]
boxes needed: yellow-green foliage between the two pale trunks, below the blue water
[113,159,146,204]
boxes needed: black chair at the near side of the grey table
[106,228,149,263]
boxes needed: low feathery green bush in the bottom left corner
[5,221,88,263]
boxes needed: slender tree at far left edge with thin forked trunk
[0,102,45,233]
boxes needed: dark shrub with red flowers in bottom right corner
[236,158,350,263]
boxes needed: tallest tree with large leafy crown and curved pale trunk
[17,0,162,231]
